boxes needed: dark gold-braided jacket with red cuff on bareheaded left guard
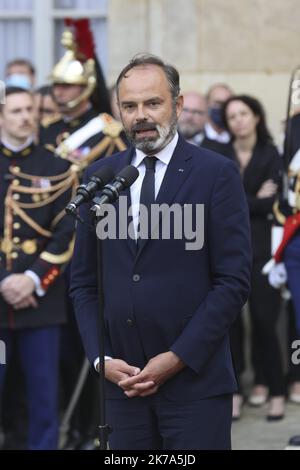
[0,144,74,328]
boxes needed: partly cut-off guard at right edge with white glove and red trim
[263,69,300,338]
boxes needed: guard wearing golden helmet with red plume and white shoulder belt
[40,20,126,176]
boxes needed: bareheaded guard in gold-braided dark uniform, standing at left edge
[0,88,77,450]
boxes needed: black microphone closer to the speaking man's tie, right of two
[91,165,139,214]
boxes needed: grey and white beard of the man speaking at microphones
[125,108,178,155]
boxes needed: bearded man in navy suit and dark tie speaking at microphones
[71,55,251,450]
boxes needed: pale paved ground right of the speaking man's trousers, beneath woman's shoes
[232,404,300,450]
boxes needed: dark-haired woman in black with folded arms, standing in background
[224,95,285,421]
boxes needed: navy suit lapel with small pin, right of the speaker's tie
[136,137,192,260]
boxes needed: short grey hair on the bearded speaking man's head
[116,54,180,101]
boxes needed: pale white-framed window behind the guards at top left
[0,0,108,85]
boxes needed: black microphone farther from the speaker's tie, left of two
[65,166,115,218]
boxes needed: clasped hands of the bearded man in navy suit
[105,351,185,398]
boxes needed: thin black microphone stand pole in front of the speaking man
[94,205,112,450]
